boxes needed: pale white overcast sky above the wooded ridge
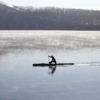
[0,0,100,10]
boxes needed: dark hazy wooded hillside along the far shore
[0,3,100,30]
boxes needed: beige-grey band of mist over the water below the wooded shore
[0,31,100,51]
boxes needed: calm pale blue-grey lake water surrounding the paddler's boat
[0,31,100,100]
